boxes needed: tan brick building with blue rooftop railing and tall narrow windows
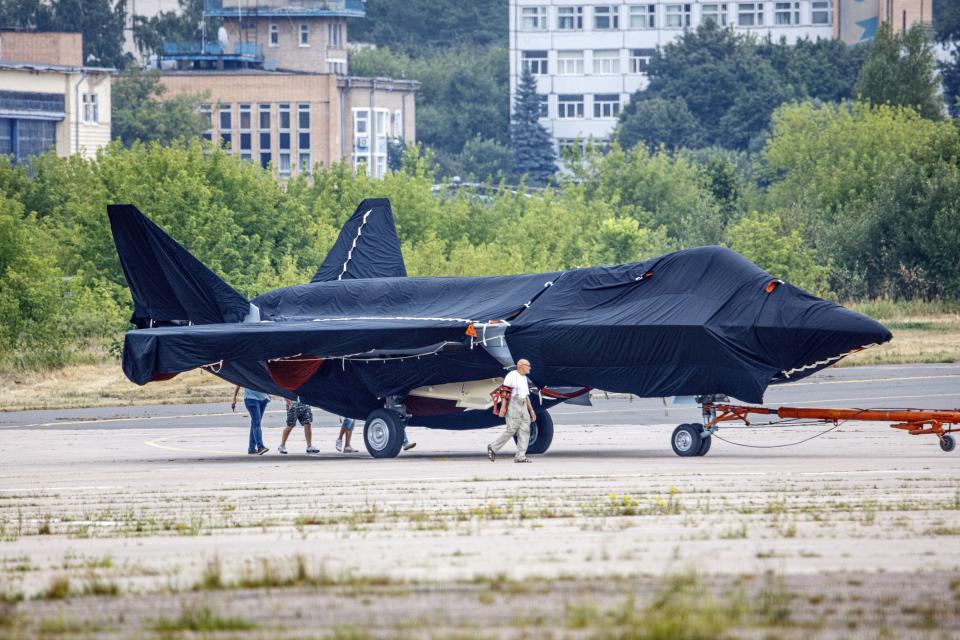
[161,0,419,177]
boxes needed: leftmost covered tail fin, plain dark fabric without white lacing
[107,204,251,327]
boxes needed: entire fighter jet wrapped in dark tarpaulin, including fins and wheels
[108,199,891,457]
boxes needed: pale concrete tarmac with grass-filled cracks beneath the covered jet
[0,364,960,637]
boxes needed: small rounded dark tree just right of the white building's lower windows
[613,97,703,151]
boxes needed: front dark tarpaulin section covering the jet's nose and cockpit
[507,247,891,402]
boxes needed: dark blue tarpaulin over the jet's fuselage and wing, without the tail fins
[112,200,891,426]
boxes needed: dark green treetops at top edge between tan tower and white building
[350,0,509,56]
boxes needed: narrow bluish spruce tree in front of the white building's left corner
[510,69,557,184]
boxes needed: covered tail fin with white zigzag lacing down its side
[310,198,407,282]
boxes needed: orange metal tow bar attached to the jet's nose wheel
[703,402,960,451]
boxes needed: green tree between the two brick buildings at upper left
[112,69,210,147]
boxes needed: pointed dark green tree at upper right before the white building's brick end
[854,23,943,120]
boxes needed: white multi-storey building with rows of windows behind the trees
[510,0,930,152]
